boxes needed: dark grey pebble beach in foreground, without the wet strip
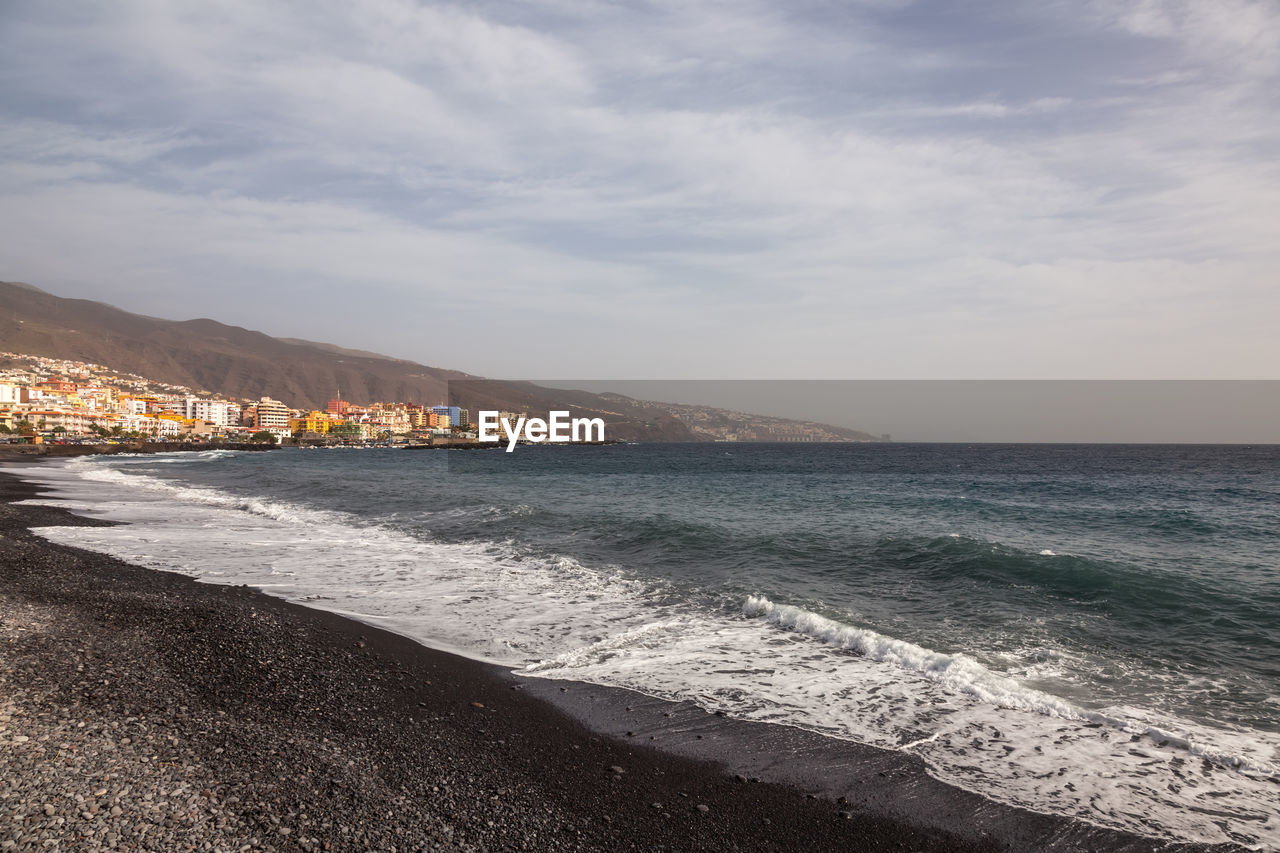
[0,474,1213,853]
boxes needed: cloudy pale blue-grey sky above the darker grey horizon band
[0,0,1280,378]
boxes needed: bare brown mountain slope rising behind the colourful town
[0,282,872,441]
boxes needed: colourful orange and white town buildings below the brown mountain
[0,352,494,444]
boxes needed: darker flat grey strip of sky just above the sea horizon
[547,379,1280,444]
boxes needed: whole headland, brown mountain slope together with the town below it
[0,282,883,446]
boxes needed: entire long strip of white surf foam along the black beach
[17,459,1280,849]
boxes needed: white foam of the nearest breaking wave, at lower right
[530,597,1280,849]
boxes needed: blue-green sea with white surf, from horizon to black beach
[15,443,1280,849]
